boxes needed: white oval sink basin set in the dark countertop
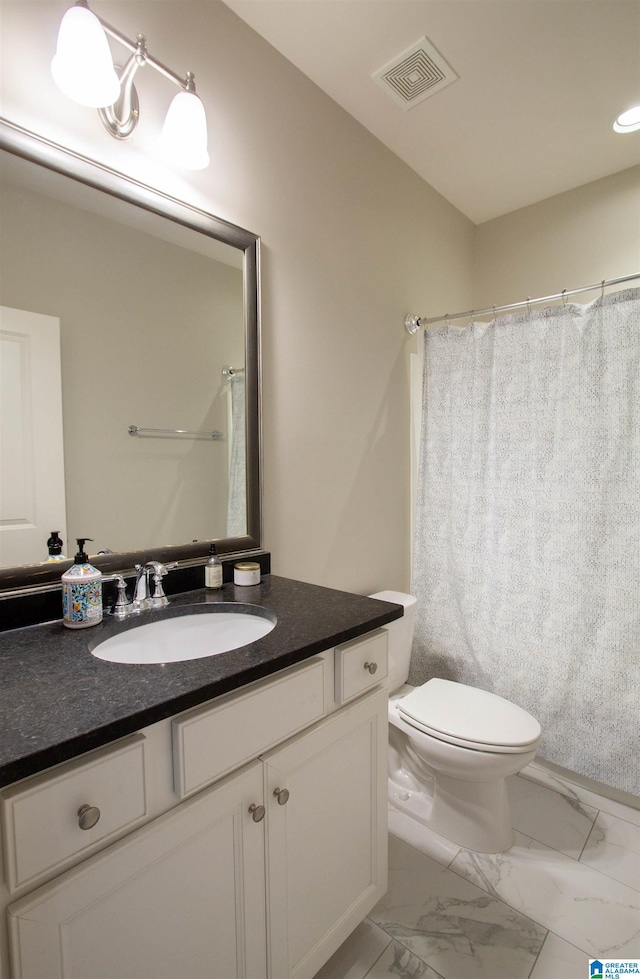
[91,604,276,663]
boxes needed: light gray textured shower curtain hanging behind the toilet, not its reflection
[409,289,640,794]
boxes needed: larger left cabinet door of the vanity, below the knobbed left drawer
[9,762,266,979]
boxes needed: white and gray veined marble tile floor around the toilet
[315,765,640,979]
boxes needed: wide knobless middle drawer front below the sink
[172,659,325,798]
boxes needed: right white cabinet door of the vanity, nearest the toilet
[263,690,388,979]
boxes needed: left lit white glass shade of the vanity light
[51,6,120,109]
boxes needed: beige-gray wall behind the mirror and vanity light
[1,0,475,593]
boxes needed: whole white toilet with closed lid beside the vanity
[370,591,542,853]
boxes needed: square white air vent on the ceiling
[371,37,458,109]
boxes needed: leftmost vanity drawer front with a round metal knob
[0,734,147,892]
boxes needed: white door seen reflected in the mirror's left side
[0,306,70,568]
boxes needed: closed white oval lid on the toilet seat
[397,679,542,749]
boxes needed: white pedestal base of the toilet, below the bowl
[389,774,513,853]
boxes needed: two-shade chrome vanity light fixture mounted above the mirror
[51,0,209,170]
